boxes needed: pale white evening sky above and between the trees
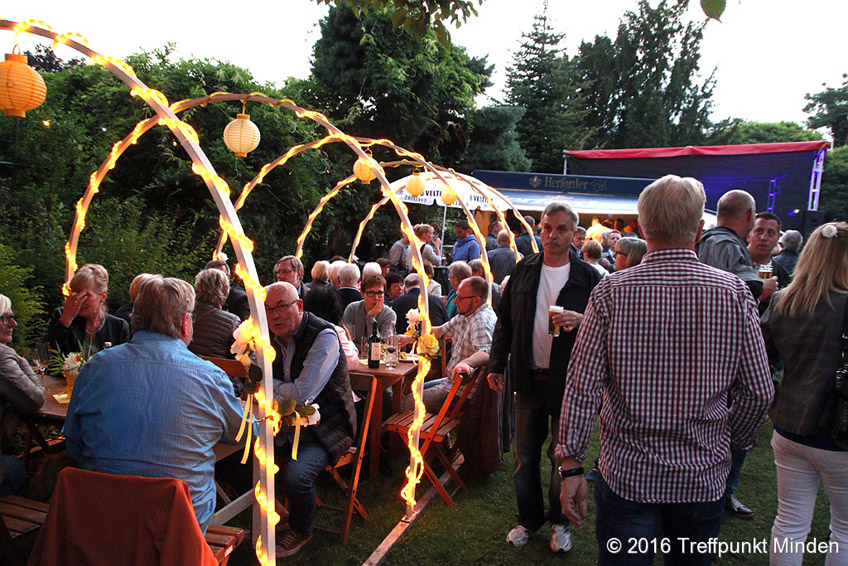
[0,0,848,130]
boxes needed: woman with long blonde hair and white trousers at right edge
[762,222,848,565]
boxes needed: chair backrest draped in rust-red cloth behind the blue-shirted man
[29,468,217,566]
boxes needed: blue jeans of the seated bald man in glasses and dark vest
[276,442,330,535]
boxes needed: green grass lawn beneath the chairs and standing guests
[224,425,830,566]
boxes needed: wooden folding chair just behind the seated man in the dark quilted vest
[315,374,381,544]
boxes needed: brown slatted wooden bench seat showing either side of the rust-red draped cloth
[0,495,246,566]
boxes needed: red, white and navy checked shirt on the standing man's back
[556,249,773,503]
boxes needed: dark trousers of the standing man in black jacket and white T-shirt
[512,381,568,532]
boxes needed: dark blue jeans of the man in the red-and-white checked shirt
[595,476,724,566]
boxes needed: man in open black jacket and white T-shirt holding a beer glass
[488,203,601,552]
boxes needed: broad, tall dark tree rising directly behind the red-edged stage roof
[577,0,715,148]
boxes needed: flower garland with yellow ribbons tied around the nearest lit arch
[230,318,321,463]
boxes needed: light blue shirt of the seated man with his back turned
[62,331,242,533]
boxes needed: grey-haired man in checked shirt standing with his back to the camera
[556,175,773,565]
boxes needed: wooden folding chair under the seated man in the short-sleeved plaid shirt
[384,370,480,505]
